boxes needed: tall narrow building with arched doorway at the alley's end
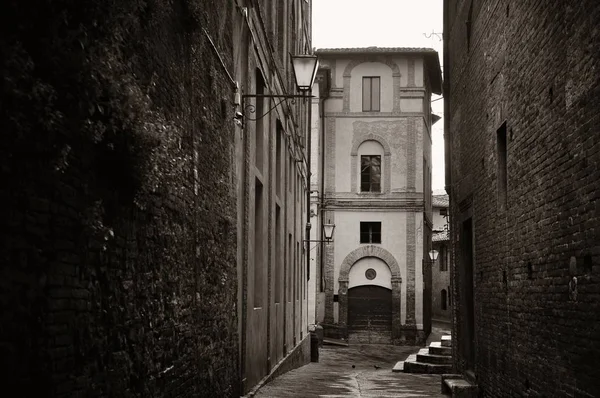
[311,47,442,344]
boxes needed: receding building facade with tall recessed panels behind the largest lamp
[233,0,314,393]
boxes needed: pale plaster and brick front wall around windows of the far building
[316,54,431,342]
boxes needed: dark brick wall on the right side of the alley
[444,0,600,397]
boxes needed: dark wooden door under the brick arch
[348,285,392,344]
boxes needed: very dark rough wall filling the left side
[0,0,239,397]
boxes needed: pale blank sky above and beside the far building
[312,0,444,190]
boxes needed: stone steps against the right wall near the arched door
[392,336,452,374]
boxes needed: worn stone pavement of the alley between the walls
[255,345,444,398]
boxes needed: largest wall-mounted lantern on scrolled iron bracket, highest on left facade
[236,54,319,121]
